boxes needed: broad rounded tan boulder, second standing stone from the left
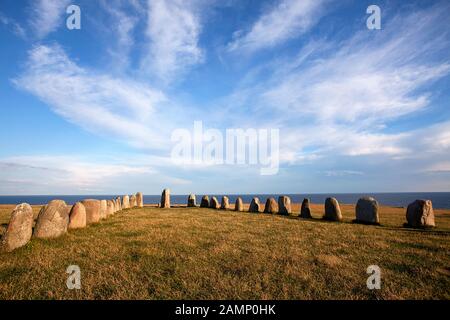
[34,200,69,238]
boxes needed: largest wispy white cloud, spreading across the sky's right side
[222,6,450,163]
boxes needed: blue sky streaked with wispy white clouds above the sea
[0,0,450,195]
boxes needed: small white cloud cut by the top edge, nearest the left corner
[29,0,70,39]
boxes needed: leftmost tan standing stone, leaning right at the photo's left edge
[0,203,33,252]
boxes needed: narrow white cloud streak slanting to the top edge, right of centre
[228,0,326,52]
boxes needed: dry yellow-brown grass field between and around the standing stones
[0,205,450,299]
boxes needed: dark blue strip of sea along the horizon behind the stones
[0,192,450,209]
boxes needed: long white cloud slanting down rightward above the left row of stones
[14,45,173,149]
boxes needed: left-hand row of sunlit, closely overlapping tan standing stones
[0,192,144,252]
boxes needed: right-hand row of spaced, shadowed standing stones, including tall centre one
[161,189,435,228]
